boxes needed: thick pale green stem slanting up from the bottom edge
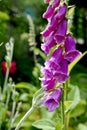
[15,107,35,130]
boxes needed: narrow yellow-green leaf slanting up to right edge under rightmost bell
[68,51,87,73]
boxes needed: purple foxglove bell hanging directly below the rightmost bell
[53,59,69,83]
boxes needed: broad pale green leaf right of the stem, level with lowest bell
[66,86,80,112]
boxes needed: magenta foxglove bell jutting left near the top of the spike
[43,4,55,19]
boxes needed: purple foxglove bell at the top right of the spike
[55,4,67,20]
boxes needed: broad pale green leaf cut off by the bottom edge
[32,119,56,130]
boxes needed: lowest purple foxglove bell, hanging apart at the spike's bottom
[44,88,62,112]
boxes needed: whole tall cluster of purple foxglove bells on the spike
[39,0,81,111]
